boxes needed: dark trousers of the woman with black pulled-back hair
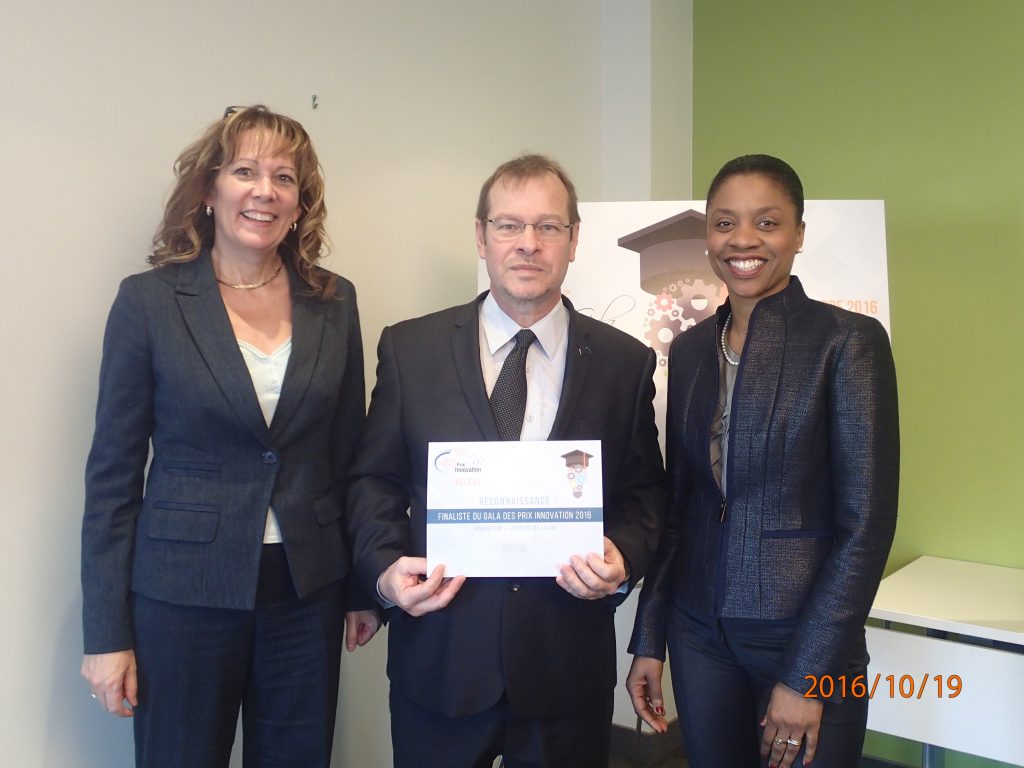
[668,607,867,768]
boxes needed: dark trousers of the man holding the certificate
[391,684,613,768]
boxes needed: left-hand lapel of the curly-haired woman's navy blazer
[175,250,269,441]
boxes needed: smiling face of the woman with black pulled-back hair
[708,173,804,307]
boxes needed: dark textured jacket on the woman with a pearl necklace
[630,278,899,692]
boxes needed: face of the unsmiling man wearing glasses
[476,173,580,327]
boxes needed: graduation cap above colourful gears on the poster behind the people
[618,208,726,366]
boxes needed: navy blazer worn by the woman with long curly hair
[82,251,366,653]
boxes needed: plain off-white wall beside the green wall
[0,0,690,768]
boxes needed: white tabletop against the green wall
[870,556,1024,645]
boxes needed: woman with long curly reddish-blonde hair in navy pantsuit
[82,106,379,768]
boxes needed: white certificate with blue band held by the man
[427,440,604,577]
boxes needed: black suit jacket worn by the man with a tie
[349,294,665,717]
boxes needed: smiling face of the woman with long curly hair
[206,131,301,258]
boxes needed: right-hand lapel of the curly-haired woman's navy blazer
[270,268,327,433]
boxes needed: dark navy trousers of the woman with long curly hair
[132,545,345,768]
